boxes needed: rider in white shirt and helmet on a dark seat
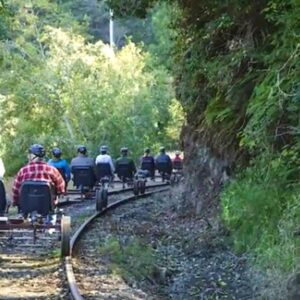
[95,145,115,182]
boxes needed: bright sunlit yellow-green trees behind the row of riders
[0,0,182,173]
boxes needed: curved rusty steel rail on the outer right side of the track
[65,183,169,300]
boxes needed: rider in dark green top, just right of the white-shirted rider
[115,147,136,183]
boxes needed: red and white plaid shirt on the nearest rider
[13,161,65,204]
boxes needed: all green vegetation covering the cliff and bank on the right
[135,0,300,290]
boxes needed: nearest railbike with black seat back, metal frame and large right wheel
[0,180,71,257]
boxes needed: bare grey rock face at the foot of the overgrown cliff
[182,126,232,215]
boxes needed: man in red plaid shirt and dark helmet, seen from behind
[12,144,65,206]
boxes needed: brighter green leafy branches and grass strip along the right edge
[222,1,300,272]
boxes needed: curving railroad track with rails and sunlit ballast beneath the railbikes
[0,183,166,299]
